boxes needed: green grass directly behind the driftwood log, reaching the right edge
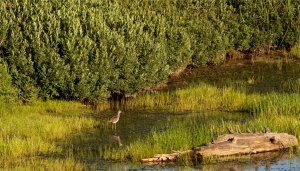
[102,111,300,164]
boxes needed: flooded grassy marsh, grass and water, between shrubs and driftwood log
[0,62,300,170]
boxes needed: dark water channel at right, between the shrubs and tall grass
[167,61,300,93]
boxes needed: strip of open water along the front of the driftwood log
[102,153,300,171]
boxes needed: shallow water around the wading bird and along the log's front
[67,110,300,171]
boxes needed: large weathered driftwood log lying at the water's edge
[142,132,298,162]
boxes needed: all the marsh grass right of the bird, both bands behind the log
[104,84,300,163]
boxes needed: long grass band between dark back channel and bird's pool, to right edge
[127,83,300,115]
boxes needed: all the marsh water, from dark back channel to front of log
[69,61,300,171]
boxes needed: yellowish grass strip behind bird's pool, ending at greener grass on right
[128,84,247,111]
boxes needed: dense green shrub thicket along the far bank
[0,0,300,102]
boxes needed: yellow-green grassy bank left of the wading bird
[0,101,97,170]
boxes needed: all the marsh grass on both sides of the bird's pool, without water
[0,80,300,167]
